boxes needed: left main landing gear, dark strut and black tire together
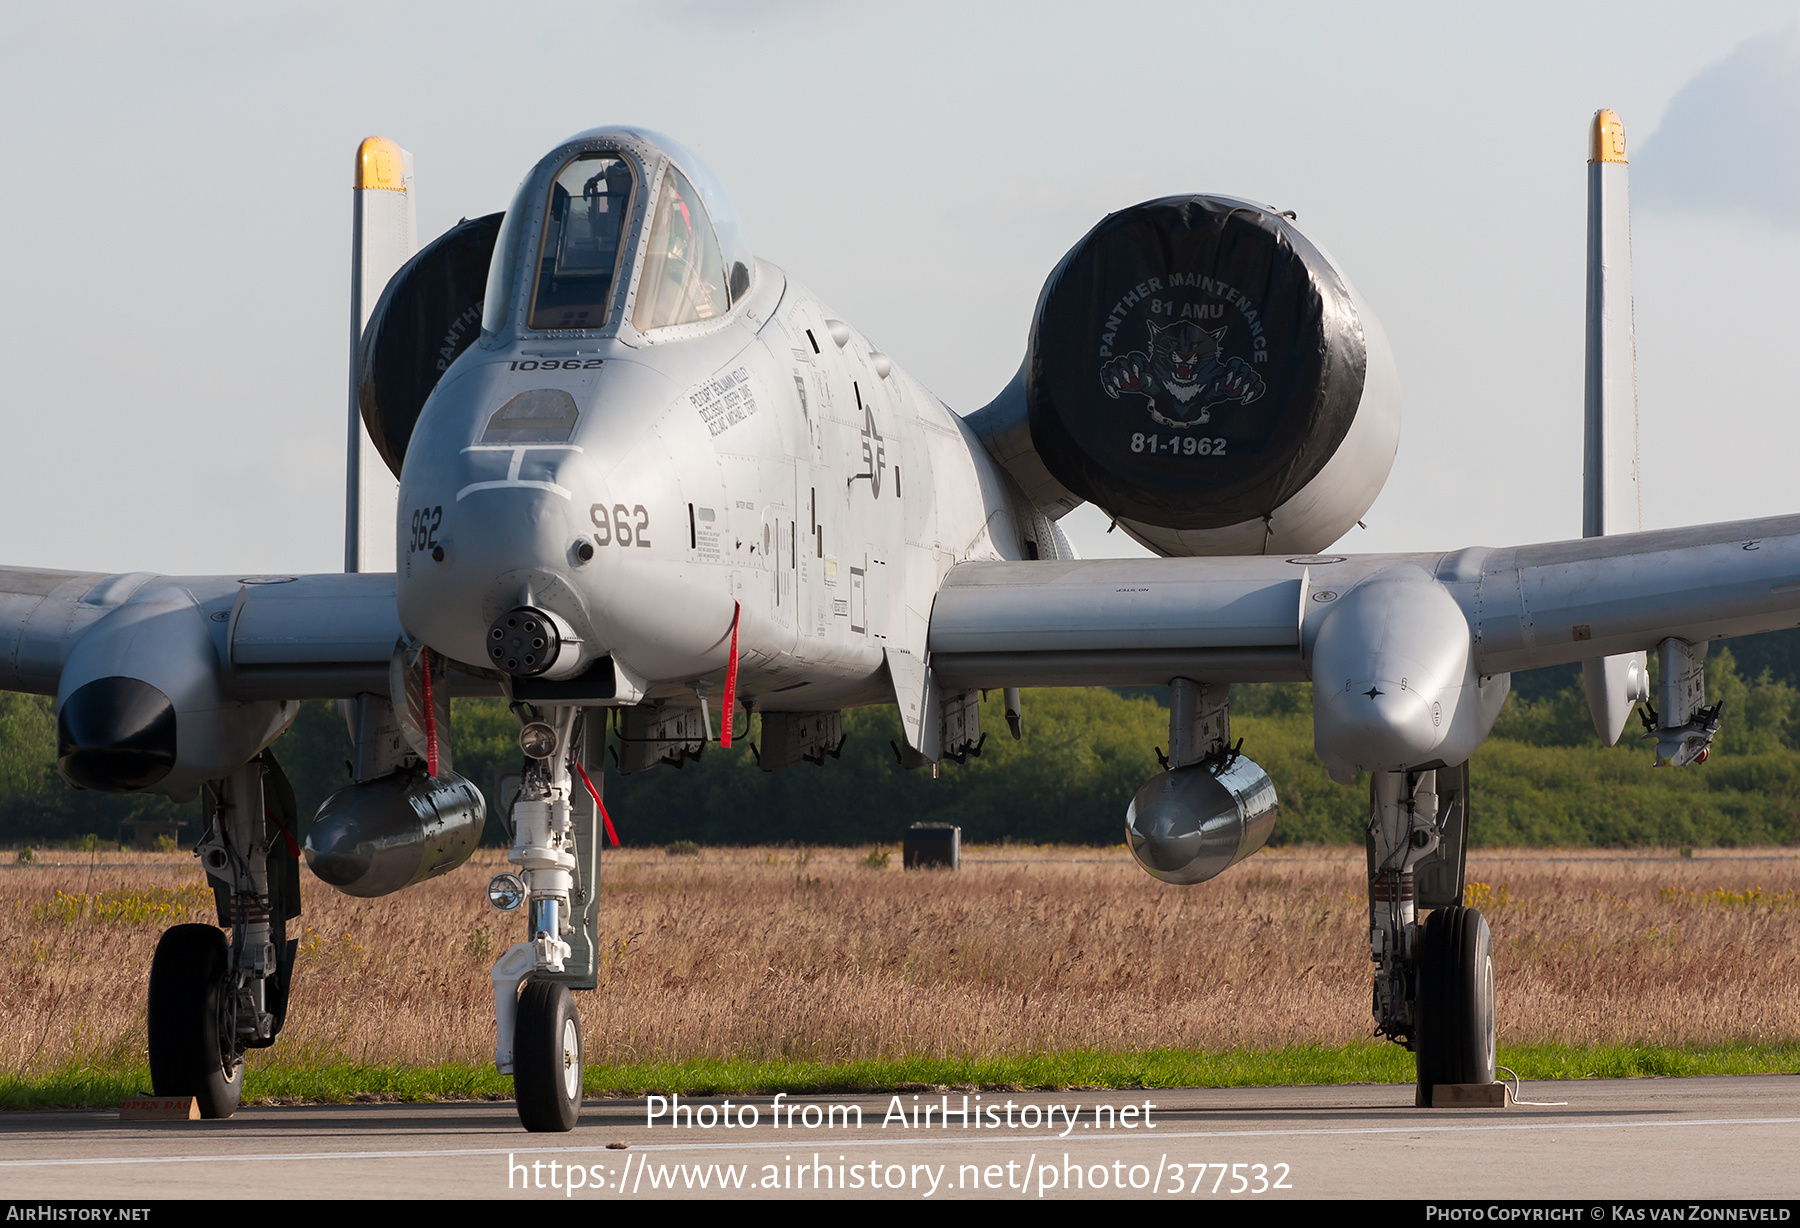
[148,751,301,1118]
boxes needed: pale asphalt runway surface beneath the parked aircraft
[0,1075,1800,1203]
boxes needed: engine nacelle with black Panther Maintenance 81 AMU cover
[972,196,1400,555]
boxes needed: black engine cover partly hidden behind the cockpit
[356,212,504,477]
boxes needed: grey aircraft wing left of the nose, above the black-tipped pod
[0,567,401,700]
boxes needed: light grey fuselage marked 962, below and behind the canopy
[396,263,1022,711]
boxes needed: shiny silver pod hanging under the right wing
[1125,754,1278,886]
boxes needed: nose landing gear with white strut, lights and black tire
[488,704,607,1133]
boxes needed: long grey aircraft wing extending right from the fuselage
[931,517,1800,688]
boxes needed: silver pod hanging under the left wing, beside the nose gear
[306,759,488,898]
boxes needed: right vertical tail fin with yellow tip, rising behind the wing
[1582,110,1651,745]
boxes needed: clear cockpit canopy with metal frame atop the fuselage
[482,128,756,342]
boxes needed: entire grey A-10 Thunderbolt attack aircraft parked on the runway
[0,112,1800,1131]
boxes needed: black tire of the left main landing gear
[148,926,243,1118]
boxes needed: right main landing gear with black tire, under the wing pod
[1368,765,1494,1107]
